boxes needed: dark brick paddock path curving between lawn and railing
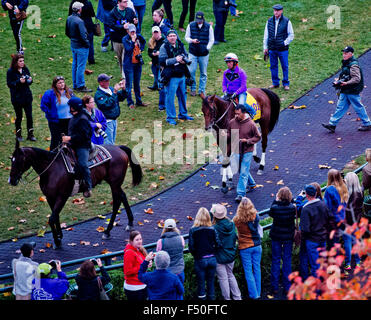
[0,50,371,294]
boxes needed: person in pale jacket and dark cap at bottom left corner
[12,242,39,300]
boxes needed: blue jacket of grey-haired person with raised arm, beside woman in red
[138,260,184,300]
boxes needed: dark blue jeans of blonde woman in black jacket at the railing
[194,257,216,300]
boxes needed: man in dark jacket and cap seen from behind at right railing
[300,184,335,280]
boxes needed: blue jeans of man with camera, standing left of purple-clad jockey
[165,77,188,121]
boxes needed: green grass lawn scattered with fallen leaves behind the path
[0,0,371,240]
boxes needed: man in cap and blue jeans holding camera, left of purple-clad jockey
[159,30,193,126]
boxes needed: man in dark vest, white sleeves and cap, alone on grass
[263,4,294,91]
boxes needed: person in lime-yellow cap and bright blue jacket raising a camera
[31,260,69,300]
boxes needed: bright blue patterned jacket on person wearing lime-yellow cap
[31,272,69,300]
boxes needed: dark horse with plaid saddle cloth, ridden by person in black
[9,141,143,249]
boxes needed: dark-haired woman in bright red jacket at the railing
[124,230,152,301]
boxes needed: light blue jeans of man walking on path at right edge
[329,93,371,126]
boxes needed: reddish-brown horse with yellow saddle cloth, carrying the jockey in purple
[201,88,281,176]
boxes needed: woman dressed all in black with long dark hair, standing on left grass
[6,53,36,142]
